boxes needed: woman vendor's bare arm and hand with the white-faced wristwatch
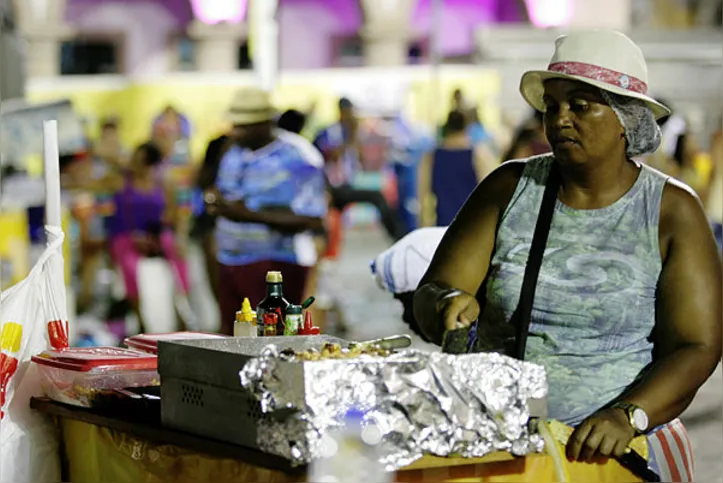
[567,181,723,460]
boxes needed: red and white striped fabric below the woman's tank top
[648,419,695,482]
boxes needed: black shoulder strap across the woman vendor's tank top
[513,161,560,360]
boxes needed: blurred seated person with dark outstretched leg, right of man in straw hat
[314,98,405,241]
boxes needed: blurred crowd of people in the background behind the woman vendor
[56,88,723,339]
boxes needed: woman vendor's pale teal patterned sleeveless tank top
[475,154,667,425]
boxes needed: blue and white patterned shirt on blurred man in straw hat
[216,129,328,267]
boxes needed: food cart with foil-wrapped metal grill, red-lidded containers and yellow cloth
[15,122,655,483]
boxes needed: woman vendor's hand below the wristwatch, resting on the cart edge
[567,409,635,462]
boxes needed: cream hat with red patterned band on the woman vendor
[520,30,670,119]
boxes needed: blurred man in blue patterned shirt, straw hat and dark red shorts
[204,88,327,334]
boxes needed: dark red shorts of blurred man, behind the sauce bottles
[218,261,309,335]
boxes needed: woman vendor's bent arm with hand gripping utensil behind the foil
[414,162,525,345]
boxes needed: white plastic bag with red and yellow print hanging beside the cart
[0,226,68,483]
